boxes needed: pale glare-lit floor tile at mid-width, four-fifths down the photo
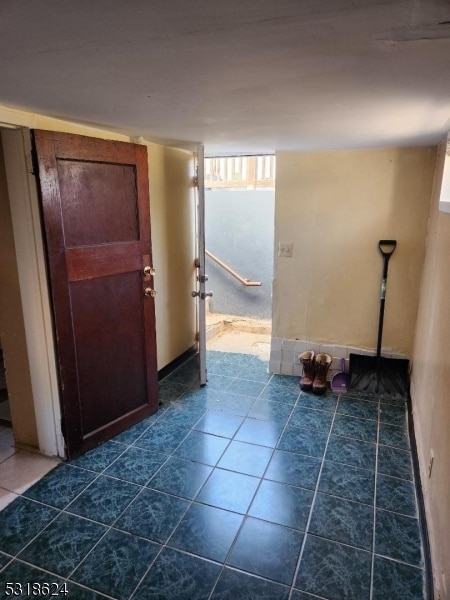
[196,468,259,513]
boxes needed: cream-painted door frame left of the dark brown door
[2,127,65,458]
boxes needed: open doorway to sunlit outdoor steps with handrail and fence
[205,155,275,360]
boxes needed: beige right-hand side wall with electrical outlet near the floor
[411,144,450,600]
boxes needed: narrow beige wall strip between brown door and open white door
[147,144,196,369]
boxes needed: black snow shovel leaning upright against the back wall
[349,240,409,398]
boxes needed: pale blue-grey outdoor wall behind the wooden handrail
[205,189,275,319]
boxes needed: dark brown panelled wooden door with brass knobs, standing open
[33,130,158,457]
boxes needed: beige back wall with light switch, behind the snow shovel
[272,148,435,355]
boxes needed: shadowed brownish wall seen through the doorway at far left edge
[0,137,38,447]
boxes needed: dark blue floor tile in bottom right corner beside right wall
[372,556,424,600]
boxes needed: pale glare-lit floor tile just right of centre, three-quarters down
[217,441,273,477]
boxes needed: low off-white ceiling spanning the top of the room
[0,0,450,155]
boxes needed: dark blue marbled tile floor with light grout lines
[0,352,425,600]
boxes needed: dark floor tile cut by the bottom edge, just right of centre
[211,568,289,600]
